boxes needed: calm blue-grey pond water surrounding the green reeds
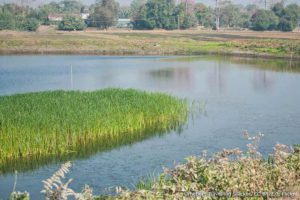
[0,56,300,199]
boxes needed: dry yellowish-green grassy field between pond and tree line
[0,29,300,59]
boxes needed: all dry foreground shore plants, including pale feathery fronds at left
[12,132,300,200]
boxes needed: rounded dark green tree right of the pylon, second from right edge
[251,10,279,31]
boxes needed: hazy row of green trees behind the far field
[0,0,300,31]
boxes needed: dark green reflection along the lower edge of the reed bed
[0,122,185,175]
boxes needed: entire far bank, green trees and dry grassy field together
[0,0,300,59]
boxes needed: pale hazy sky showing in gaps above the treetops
[0,0,300,5]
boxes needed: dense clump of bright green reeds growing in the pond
[0,89,188,172]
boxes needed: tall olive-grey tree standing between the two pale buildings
[90,0,119,29]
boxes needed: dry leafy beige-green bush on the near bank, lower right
[116,134,300,199]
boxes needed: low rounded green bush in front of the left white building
[58,16,86,31]
